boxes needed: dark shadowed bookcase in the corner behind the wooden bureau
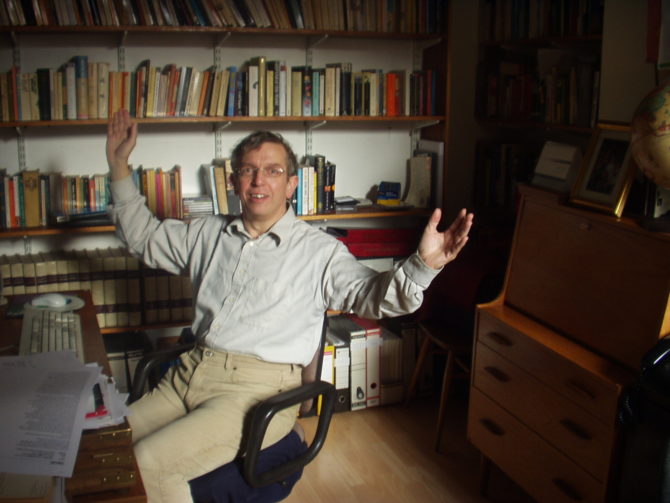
[473,0,604,242]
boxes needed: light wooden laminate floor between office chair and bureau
[285,397,532,503]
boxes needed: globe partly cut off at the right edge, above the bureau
[631,82,670,189]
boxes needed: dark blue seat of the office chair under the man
[190,431,307,503]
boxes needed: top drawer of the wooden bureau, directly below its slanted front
[477,310,621,424]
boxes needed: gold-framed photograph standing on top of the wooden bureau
[570,124,635,217]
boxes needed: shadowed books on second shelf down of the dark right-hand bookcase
[478,49,600,128]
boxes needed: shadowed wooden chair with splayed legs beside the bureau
[405,247,505,451]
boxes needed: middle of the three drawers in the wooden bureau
[474,343,614,482]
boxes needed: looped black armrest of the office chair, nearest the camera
[243,381,336,487]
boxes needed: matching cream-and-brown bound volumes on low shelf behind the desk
[0,248,193,328]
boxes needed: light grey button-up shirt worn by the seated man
[111,176,439,365]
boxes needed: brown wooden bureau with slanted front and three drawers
[468,187,670,503]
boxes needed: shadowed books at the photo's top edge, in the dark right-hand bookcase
[479,0,604,42]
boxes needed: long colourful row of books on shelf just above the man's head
[0,55,437,122]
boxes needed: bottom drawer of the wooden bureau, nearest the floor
[468,388,605,503]
